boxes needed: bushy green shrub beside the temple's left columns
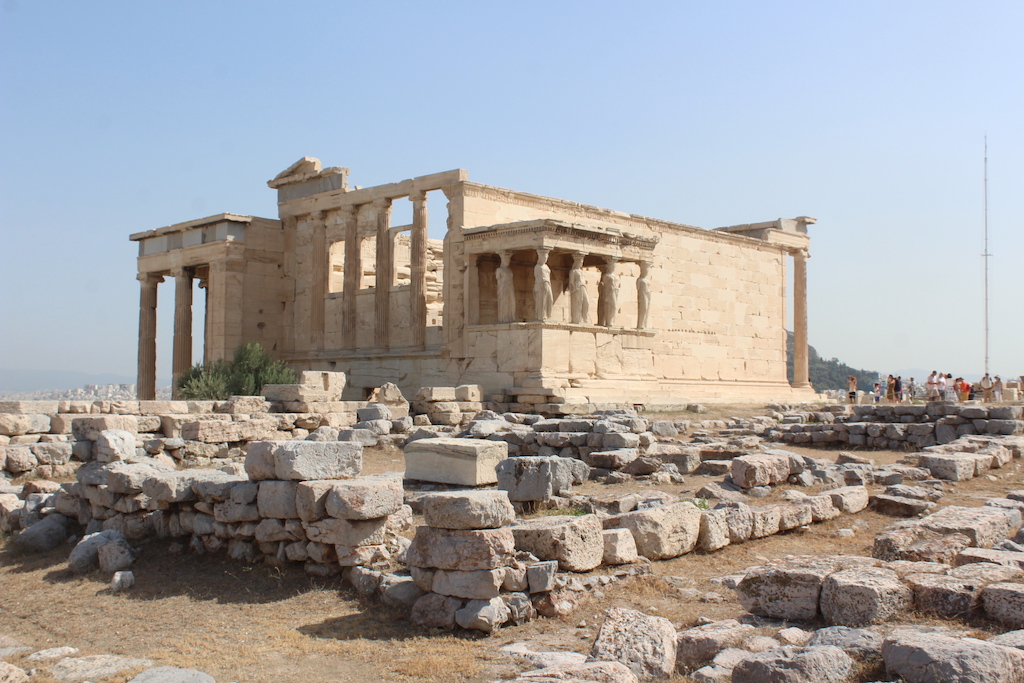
[178,342,299,400]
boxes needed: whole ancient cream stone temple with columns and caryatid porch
[131,158,814,412]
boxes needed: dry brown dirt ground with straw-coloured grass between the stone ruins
[0,407,1024,683]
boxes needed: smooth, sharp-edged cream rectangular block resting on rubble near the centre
[404,437,508,486]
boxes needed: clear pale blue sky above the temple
[0,0,1024,385]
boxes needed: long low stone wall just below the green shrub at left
[0,396,412,479]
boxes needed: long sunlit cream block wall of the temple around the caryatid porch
[445,181,798,403]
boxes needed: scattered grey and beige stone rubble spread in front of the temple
[6,395,1024,681]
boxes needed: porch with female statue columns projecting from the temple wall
[463,220,657,387]
